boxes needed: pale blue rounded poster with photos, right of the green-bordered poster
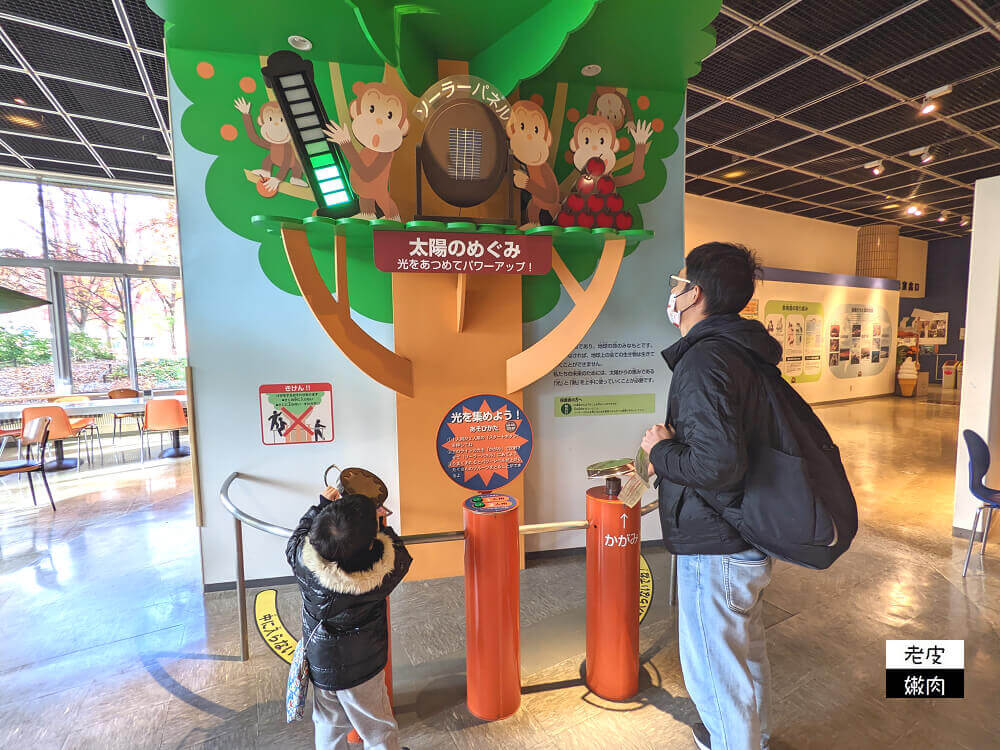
[829,305,893,378]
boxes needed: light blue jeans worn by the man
[677,549,771,750]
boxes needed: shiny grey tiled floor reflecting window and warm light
[0,399,1000,750]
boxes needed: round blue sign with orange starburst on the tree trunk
[437,394,533,492]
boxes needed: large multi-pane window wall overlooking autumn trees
[0,181,187,400]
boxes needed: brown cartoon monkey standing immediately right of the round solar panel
[507,99,560,229]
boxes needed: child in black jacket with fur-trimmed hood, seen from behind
[285,487,411,750]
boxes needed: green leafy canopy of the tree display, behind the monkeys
[149,0,720,323]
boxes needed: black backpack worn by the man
[733,347,858,570]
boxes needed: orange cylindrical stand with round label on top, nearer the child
[463,494,521,721]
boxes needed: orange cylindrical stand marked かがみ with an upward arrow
[587,487,640,701]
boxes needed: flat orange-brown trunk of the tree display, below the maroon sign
[392,274,531,579]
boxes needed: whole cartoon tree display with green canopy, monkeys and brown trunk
[149,0,720,577]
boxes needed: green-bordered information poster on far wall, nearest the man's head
[764,300,826,383]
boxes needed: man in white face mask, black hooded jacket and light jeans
[643,242,781,750]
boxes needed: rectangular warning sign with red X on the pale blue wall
[260,383,333,445]
